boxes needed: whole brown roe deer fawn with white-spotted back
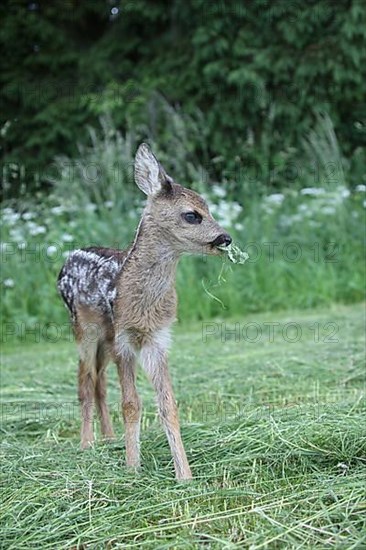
[58,144,231,480]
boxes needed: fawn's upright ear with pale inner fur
[135,143,171,195]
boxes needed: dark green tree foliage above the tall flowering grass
[0,0,366,196]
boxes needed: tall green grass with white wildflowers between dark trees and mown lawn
[1,113,366,332]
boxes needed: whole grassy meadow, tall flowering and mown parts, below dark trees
[0,116,366,550]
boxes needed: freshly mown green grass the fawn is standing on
[0,305,366,550]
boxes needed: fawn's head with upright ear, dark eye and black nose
[135,147,231,254]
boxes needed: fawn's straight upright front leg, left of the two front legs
[117,353,141,468]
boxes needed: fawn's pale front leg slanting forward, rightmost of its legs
[141,345,192,480]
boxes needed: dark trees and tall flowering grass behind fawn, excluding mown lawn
[0,0,366,338]
